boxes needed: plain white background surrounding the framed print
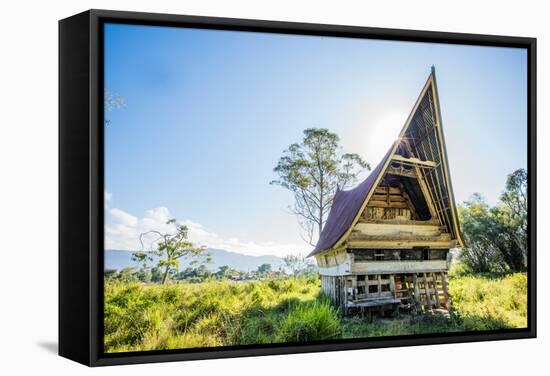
[0,0,550,376]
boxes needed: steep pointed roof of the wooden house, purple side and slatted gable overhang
[308,67,464,257]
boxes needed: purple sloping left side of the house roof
[307,145,393,257]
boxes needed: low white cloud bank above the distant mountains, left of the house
[105,207,308,256]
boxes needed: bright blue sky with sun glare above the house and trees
[105,24,527,255]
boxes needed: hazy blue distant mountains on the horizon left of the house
[105,248,284,272]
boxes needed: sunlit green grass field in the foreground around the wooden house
[105,273,527,352]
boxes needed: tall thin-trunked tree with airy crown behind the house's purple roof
[271,128,370,245]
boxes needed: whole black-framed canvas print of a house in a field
[59,10,536,366]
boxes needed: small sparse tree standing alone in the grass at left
[133,219,211,284]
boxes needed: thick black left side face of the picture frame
[58,11,93,365]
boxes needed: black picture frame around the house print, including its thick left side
[59,10,537,366]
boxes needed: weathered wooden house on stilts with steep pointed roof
[309,68,463,314]
